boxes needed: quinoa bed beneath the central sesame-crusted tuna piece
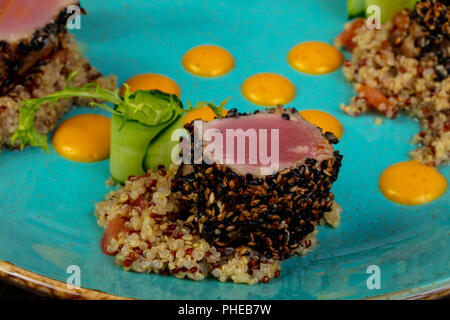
[95,166,338,284]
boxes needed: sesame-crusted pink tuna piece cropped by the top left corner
[0,0,78,96]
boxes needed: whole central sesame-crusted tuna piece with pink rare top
[173,107,342,259]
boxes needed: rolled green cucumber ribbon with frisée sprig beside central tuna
[11,73,226,183]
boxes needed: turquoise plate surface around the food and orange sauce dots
[0,0,450,299]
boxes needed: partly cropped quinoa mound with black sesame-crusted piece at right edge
[335,0,450,166]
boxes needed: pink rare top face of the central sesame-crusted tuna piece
[203,114,333,172]
